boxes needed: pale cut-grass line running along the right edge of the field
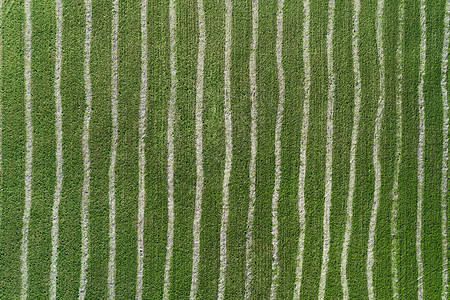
[441,0,450,300]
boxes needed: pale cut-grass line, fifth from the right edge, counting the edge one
[341,0,361,300]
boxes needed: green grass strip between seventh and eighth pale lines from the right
[278,1,305,299]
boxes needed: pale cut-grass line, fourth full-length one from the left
[108,0,119,299]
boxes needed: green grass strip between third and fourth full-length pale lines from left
[86,2,112,299]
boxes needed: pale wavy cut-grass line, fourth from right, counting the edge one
[366,0,386,300]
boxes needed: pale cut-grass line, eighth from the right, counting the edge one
[270,0,285,300]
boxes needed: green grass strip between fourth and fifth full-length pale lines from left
[116,1,141,299]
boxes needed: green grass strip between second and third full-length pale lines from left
[57,0,85,299]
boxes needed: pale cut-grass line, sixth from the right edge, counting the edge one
[318,0,335,299]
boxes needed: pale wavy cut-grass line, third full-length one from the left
[78,0,92,300]
